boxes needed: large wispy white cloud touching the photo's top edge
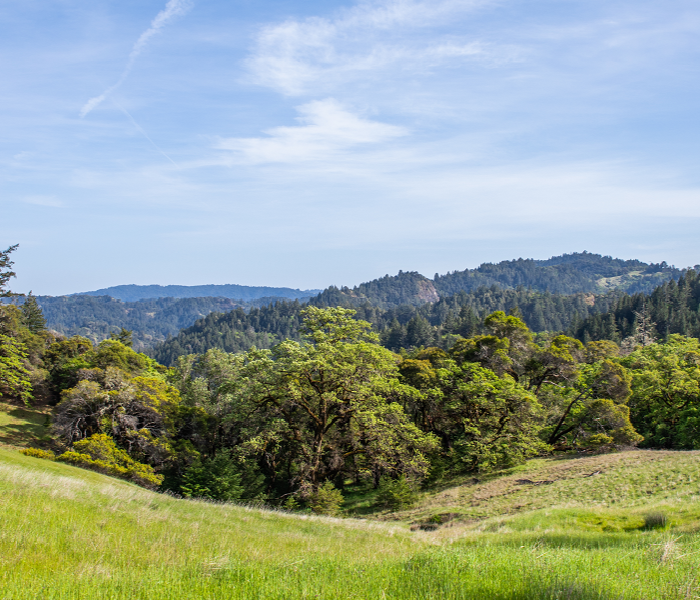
[247,0,500,96]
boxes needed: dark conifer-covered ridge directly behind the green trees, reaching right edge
[152,270,700,364]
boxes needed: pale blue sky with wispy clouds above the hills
[0,0,700,295]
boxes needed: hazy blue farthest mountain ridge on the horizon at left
[70,284,321,302]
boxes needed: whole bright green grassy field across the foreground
[0,450,700,600]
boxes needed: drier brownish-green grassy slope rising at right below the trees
[392,450,700,527]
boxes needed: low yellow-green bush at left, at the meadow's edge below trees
[56,433,163,489]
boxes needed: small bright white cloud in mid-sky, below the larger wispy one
[217,98,408,164]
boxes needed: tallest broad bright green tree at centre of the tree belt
[197,307,435,499]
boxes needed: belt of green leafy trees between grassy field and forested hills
[0,244,700,512]
